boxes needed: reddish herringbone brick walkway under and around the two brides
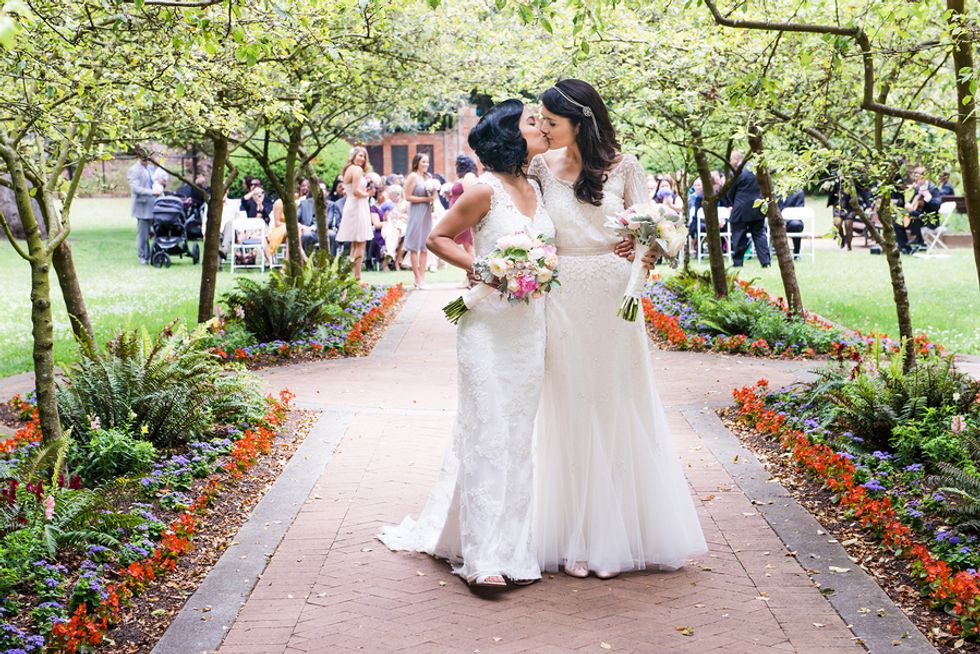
[216,289,864,654]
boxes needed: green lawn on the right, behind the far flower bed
[676,245,980,354]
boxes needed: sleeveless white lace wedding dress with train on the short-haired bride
[378,173,555,580]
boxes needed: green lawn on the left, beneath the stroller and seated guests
[0,198,461,377]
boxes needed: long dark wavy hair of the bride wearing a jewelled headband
[541,79,620,206]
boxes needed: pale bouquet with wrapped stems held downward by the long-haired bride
[606,204,687,322]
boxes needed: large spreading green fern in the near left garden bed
[58,326,259,448]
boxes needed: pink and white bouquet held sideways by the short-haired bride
[442,232,558,324]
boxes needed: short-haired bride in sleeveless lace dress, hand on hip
[379,100,555,587]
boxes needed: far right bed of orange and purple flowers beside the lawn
[643,278,942,359]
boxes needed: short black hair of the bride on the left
[468,99,527,175]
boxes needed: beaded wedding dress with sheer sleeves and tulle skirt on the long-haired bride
[530,155,707,573]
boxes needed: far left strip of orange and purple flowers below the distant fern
[210,284,405,366]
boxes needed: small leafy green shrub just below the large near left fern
[68,429,157,486]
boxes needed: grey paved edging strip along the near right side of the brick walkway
[682,409,937,654]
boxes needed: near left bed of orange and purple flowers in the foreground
[0,391,293,654]
